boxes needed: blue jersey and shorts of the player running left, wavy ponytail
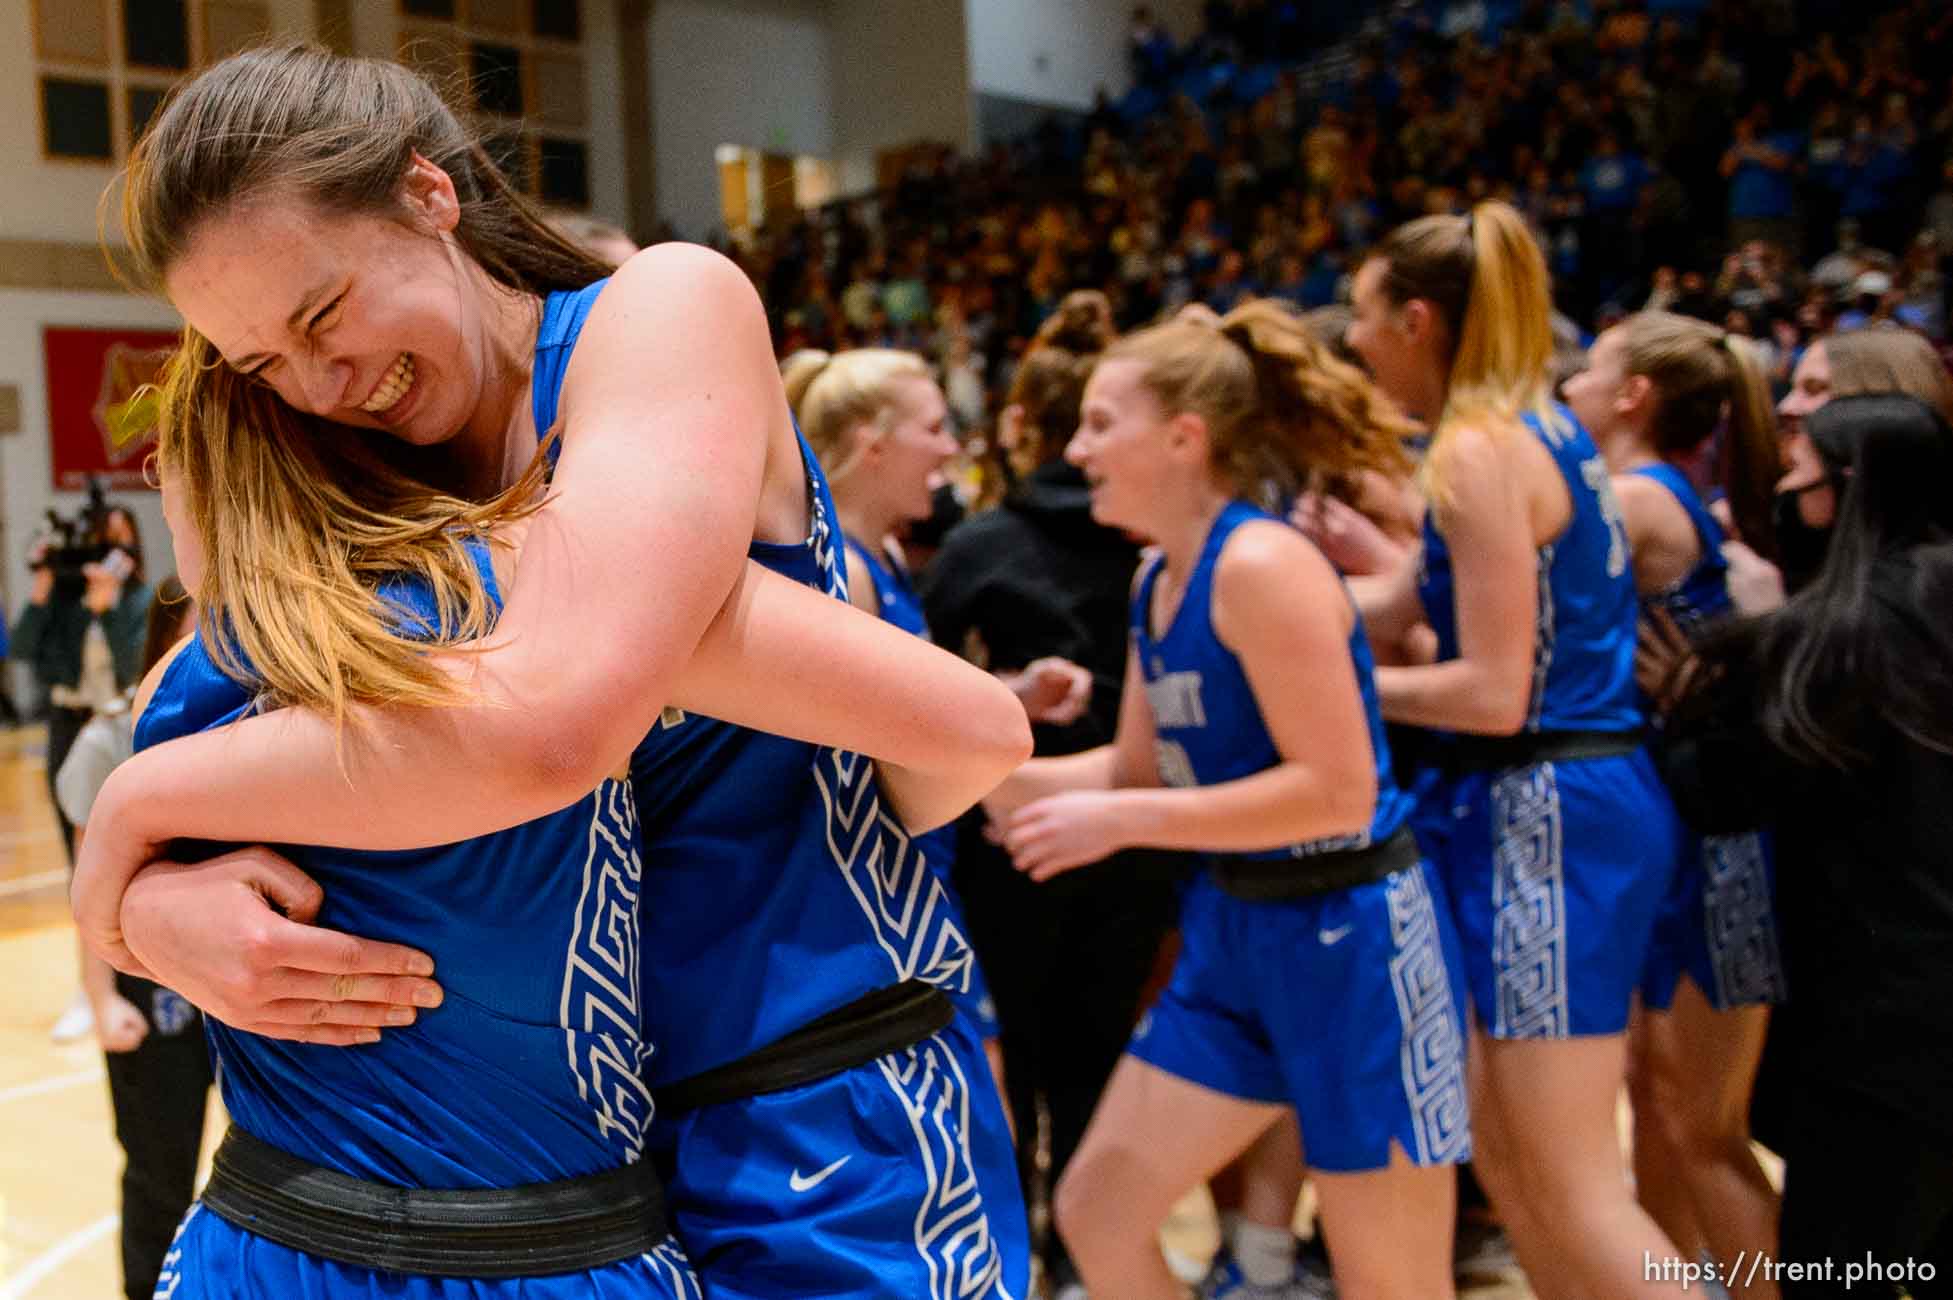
[1131,502,1471,1171]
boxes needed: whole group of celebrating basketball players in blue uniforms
[61,35,1943,1300]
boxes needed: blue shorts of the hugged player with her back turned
[154,1202,705,1300]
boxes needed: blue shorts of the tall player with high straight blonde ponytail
[1412,750,1683,1038]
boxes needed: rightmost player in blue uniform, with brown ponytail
[1566,312,1785,1294]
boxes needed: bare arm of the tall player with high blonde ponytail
[1377,429,1557,736]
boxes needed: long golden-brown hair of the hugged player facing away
[156,330,547,726]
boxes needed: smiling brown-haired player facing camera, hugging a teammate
[76,40,1027,1296]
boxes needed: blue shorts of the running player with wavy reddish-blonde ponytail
[1129,865,1471,1173]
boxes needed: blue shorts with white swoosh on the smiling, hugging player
[650,1017,1031,1300]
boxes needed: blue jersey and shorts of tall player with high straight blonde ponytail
[1414,406,1682,1038]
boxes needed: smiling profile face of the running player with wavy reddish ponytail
[1064,359,1176,537]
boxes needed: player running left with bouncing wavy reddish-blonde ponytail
[986,303,1471,1300]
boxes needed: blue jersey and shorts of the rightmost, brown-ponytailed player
[1633,463,1789,1011]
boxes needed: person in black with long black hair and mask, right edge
[1664,394,1953,1298]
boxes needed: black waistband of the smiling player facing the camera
[656,980,957,1117]
